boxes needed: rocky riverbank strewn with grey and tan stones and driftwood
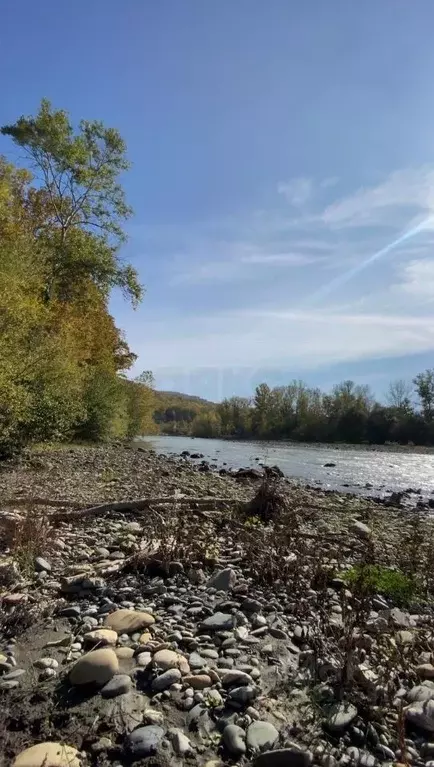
[0,446,434,767]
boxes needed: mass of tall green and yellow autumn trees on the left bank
[0,101,154,458]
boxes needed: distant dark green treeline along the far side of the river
[154,370,434,445]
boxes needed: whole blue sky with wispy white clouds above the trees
[0,0,434,399]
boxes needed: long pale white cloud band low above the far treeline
[133,309,434,372]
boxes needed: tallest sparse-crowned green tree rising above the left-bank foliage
[1,99,143,305]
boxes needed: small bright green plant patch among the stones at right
[342,565,416,606]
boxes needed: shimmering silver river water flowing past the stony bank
[138,436,434,497]
